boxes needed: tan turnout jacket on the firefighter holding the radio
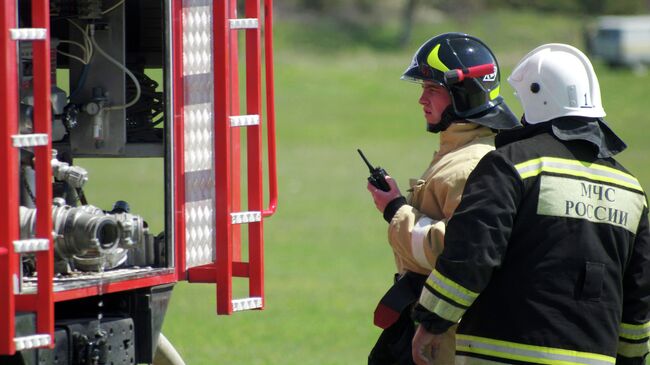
[388,123,494,365]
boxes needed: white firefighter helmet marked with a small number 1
[508,43,605,124]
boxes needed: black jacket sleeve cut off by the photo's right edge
[616,208,650,365]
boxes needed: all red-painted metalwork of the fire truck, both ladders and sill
[0,0,277,354]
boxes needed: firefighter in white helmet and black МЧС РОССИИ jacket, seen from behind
[413,44,650,365]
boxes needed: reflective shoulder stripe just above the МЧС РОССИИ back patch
[515,157,643,191]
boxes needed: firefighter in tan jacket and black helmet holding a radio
[368,33,520,365]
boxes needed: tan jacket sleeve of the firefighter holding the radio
[388,160,478,275]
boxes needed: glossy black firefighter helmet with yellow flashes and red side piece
[402,33,521,129]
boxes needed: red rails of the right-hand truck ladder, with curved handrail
[182,0,277,314]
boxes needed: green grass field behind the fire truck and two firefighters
[80,8,650,365]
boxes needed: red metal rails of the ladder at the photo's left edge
[0,0,54,354]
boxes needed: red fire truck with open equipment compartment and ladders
[0,0,277,365]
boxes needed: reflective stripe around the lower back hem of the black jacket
[456,334,616,365]
